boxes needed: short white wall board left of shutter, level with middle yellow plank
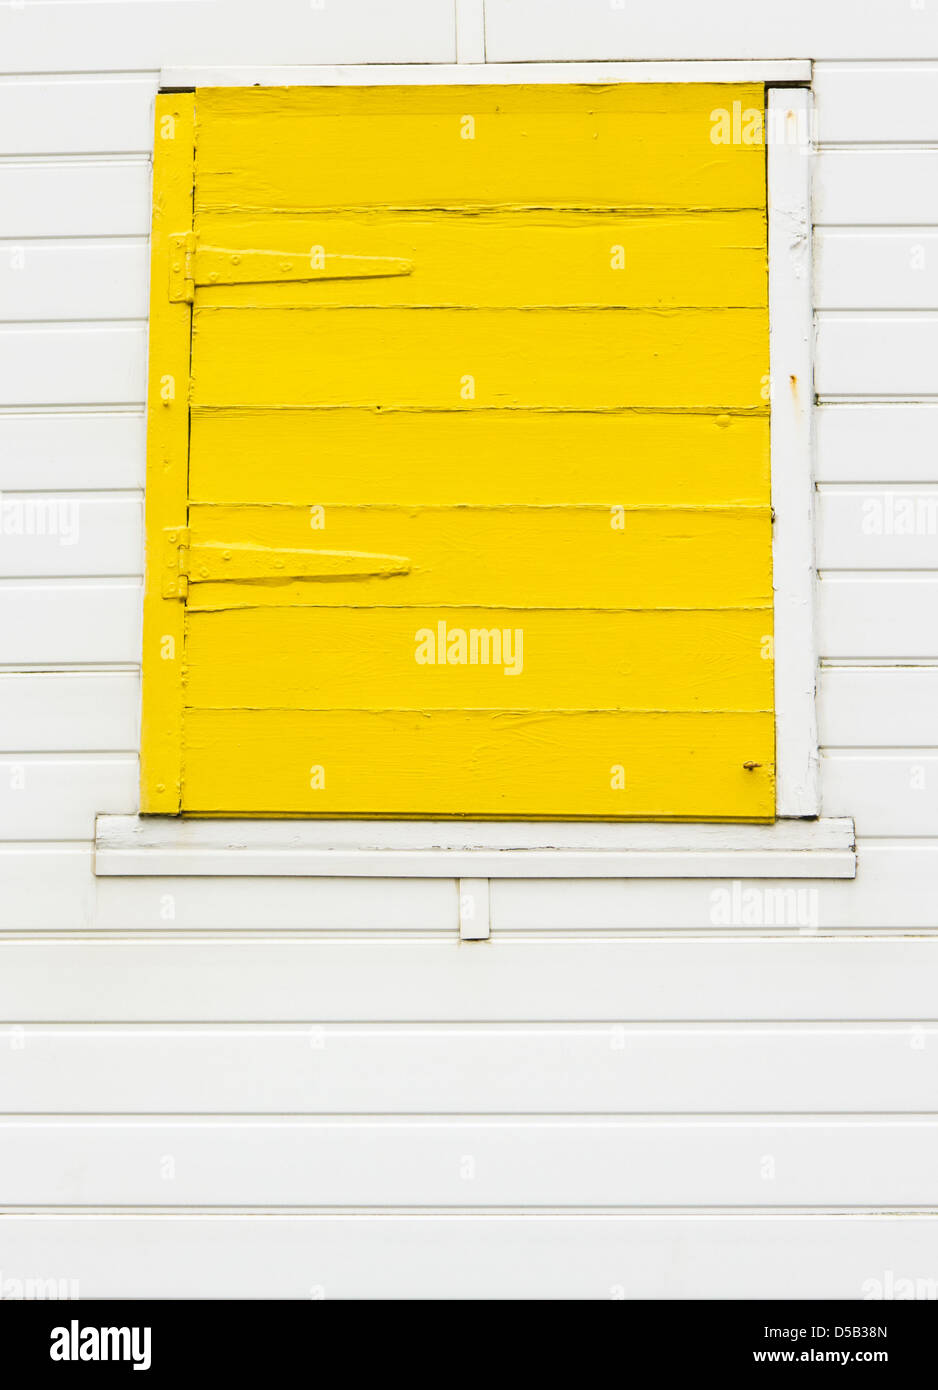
[0,410,146,492]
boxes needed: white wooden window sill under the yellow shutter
[94,816,856,878]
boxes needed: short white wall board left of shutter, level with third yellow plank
[0,322,146,407]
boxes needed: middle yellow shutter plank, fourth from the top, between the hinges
[189,409,770,507]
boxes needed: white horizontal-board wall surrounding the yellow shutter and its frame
[0,0,938,1298]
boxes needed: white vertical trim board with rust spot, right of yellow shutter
[766,89,820,816]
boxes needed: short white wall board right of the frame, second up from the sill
[818,666,938,748]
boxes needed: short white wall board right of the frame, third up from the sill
[818,573,938,662]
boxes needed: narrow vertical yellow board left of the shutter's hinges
[140,93,193,813]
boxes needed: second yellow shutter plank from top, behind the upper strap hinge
[196,210,768,309]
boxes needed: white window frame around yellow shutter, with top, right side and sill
[94,62,856,878]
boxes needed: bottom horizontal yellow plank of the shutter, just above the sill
[185,710,774,820]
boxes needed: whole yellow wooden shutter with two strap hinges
[137,85,774,820]
